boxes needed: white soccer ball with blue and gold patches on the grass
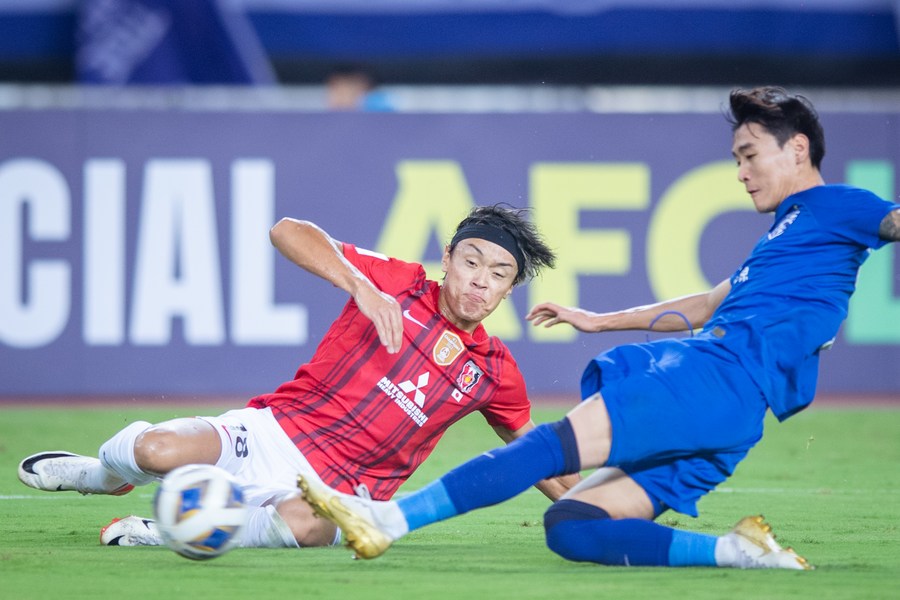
[153,465,247,560]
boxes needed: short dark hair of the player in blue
[726,86,825,169]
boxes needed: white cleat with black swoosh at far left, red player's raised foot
[19,450,134,496]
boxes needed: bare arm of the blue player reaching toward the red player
[525,279,731,333]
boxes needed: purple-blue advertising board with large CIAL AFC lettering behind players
[0,110,900,396]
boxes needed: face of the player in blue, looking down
[731,123,808,213]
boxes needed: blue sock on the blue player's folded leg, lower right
[544,500,717,567]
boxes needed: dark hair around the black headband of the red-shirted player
[449,203,556,285]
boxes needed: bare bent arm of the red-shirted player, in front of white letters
[269,218,403,354]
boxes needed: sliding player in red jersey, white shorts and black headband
[19,206,577,547]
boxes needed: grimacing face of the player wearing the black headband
[439,238,518,332]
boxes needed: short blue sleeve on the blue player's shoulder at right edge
[815,186,900,249]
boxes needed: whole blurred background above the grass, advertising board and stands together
[0,0,900,401]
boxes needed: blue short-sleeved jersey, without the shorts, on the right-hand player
[698,185,898,420]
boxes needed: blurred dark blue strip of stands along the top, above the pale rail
[0,0,900,88]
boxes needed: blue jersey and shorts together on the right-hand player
[581,185,898,516]
